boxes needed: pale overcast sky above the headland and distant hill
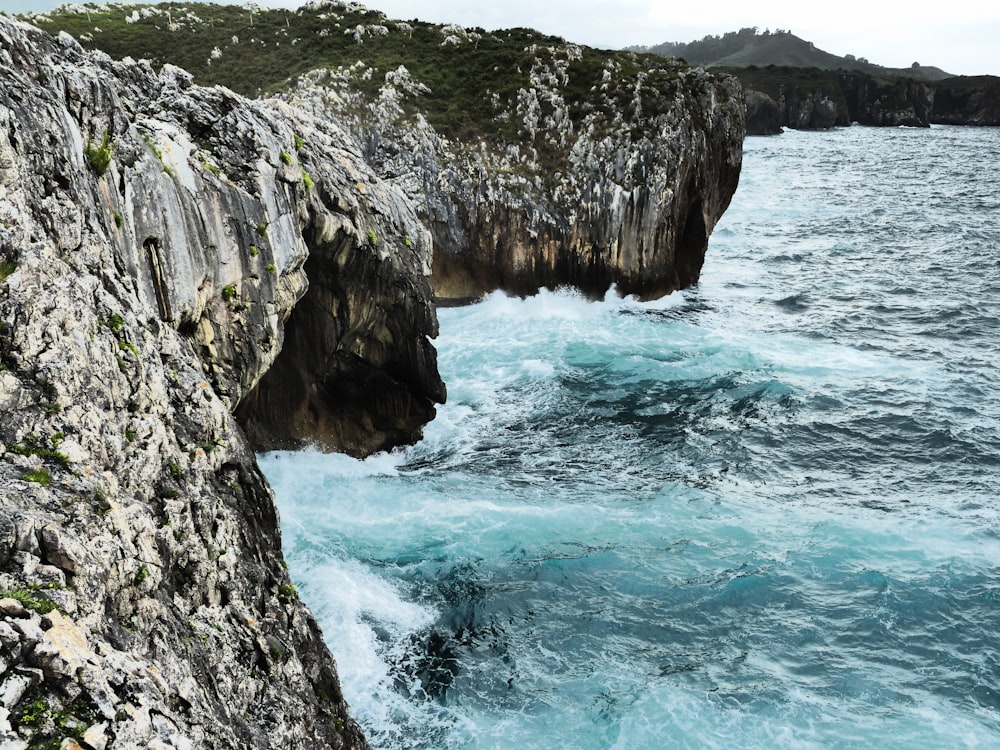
[0,0,1000,75]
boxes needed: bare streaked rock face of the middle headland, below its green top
[288,45,744,303]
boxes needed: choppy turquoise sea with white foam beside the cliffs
[260,126,1000,750]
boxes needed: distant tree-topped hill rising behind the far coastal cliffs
[635,28,951,81]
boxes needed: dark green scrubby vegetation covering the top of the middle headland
[27,2,687,139]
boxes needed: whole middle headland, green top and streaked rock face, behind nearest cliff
[23,2,744,302]
